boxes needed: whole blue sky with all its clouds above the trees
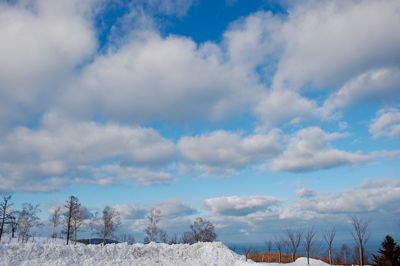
[0,0,400,243]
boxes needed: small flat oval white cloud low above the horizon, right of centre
[204,196,280,216]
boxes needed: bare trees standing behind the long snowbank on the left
[0,195,217,245]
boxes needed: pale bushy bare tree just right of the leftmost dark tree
[17,203,41,242]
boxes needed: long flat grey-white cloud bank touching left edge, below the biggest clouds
[0,116,175,191]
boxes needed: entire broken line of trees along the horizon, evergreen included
[0,195,400,266]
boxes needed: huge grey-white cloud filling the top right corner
[274,1,400,88]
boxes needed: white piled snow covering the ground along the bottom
[0,240,327,266]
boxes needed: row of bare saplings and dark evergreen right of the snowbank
[252,216,400,266]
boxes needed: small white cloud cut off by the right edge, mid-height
[369,108,400,138]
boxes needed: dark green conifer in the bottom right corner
[373,235,400,266]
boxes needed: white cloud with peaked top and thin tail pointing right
[272,127,372,172]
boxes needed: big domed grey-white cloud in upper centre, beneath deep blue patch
[56,31,261,122]
